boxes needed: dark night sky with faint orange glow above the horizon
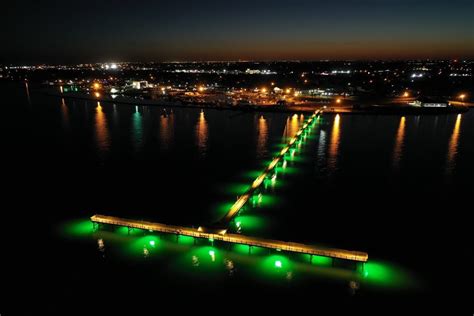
[0,0,474,63]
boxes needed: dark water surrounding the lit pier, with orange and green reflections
[0,84,474,313]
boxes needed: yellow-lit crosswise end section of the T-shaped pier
[90,215,369,262]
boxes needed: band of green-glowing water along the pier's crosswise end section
[62,220,420,289]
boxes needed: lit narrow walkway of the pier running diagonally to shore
[214,110,322,229]
